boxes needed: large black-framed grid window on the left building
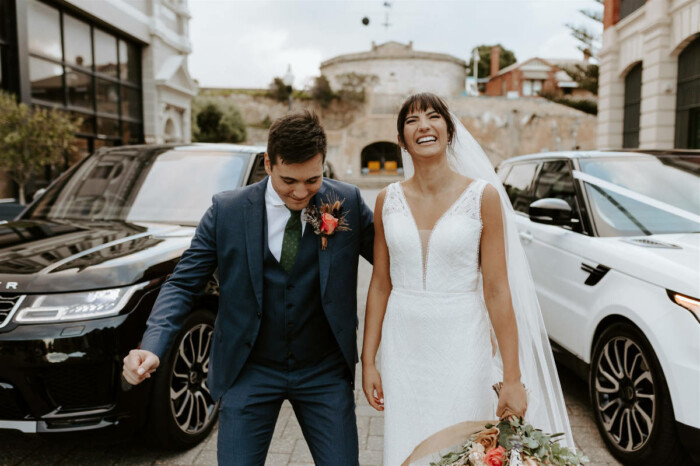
[25,0,143,153]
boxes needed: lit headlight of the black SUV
[15,283,147,323]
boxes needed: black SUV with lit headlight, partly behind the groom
[0,144,276,447]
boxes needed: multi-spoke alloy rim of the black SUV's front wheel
[170,324,218,434]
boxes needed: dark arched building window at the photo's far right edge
[676,36,700,149]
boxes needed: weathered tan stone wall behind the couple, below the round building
[213,94,596,185]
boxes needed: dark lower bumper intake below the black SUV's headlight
[44,364,115,410]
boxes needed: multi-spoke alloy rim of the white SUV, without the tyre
[594,336,656,452]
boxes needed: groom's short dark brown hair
[267,110,327,165]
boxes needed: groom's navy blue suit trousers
[217,351,359,466]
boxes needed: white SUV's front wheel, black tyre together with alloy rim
[589,323,687,465]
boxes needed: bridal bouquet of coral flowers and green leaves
[430,416,588,466]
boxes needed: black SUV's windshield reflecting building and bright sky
[25,148,250,225]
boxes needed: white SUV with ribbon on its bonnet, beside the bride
[498,151,700,464]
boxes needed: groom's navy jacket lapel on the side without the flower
[245,178,267,309]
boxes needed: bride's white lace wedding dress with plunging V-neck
[381,180,500,466]
